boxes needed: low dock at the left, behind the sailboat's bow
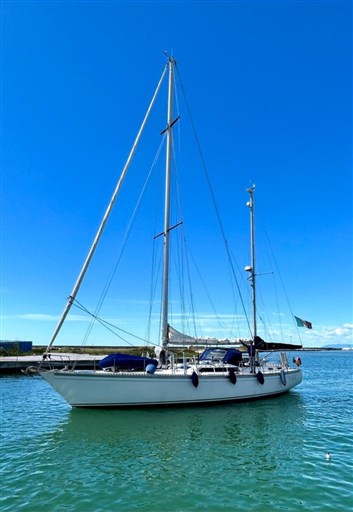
[0,352,105,375]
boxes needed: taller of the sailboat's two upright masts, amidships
[162,57,176,348]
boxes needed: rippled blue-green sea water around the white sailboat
[0,352,353,512]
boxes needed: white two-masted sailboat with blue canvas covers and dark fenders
[39,56,302,407]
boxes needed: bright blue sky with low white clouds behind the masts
[0,1,353,346]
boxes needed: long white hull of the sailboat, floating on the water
[41,368,302,407]
